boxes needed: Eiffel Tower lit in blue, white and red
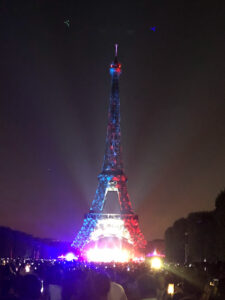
[72,44,146,252]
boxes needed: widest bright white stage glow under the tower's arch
[87,247,130,262]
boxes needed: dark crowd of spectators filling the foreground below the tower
[0,259,225,300]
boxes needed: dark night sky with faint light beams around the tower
[0,0,225,241]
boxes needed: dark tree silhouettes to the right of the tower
[165,190,225,262]
